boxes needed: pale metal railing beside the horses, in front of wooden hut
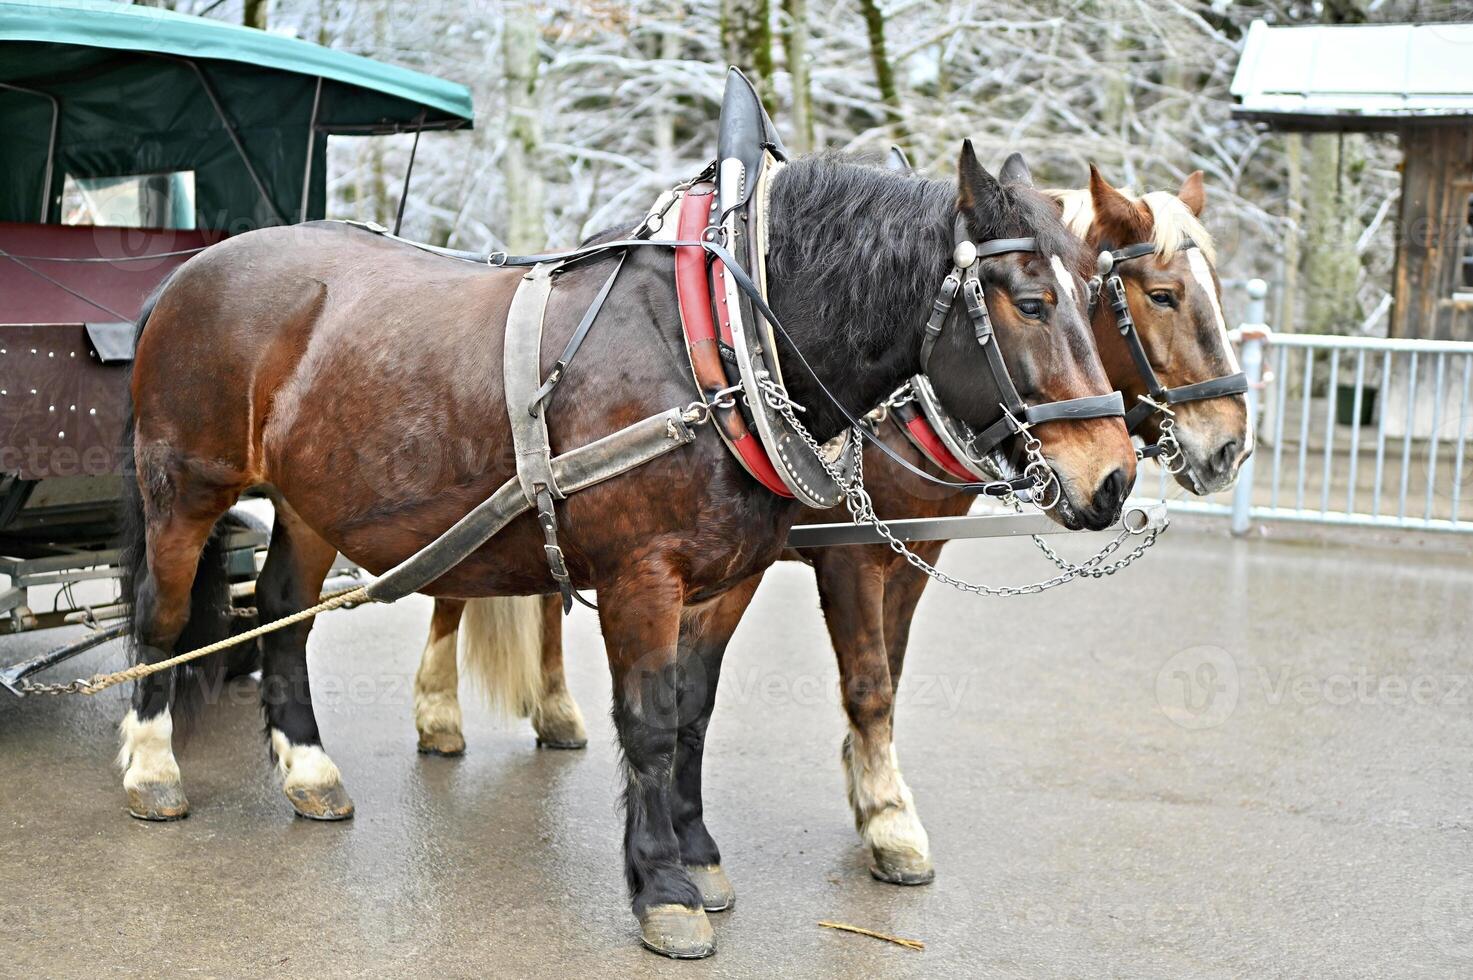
[1143,280,1473,533]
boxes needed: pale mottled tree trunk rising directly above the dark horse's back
[501,7,546,252]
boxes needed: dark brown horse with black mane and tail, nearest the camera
[114,144,1136,956]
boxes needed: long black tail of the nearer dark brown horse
[118,274,233,732]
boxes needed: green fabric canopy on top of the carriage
[0,0,471,233]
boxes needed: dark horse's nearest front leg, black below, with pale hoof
[598,559,716,959]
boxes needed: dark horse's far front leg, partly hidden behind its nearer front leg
[675,575,762,912]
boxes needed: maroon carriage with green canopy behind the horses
[0,0,471,693]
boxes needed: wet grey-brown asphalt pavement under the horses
[0,525,1473,979]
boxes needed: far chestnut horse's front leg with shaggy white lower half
[815,548,935,884]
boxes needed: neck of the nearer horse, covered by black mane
[767,172,956,439]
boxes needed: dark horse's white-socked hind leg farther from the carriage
[256,501,354,819]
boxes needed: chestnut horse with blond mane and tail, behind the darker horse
[415,167,1252,902]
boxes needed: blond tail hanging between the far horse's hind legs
[460,595,542,718]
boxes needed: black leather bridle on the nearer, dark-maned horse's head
[921,215,1125,461]
